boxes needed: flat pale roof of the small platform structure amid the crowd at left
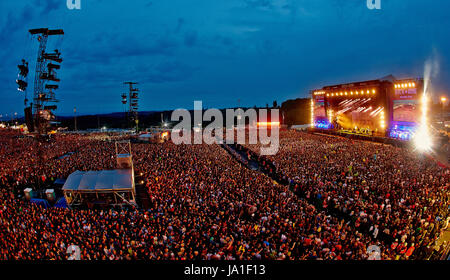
[63,169,133,192]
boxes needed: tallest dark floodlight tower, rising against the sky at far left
[29,28,64,134]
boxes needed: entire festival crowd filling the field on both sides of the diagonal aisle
[0,127,449,260]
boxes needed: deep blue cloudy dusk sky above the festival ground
[0,0,450,115]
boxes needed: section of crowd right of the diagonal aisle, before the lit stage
[246,130,450,259]
